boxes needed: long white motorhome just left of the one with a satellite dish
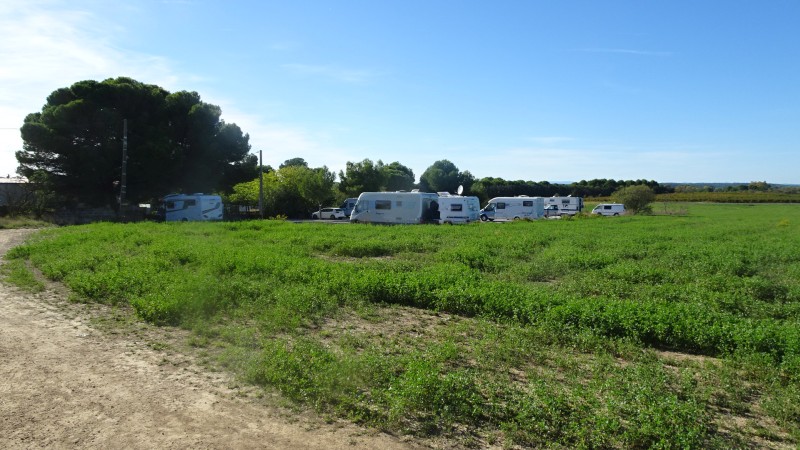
[350,191,439,224]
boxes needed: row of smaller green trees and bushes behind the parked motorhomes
[219,158,669,217]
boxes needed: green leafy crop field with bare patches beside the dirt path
[7,204,800,448]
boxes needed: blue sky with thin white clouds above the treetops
[0,0,800,183]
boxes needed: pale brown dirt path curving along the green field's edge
[0,230,412,450]
